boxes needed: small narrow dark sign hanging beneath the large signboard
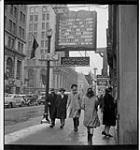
[61,57,90,66]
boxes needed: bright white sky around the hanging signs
[68,5,108,74]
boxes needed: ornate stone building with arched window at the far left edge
[4,5,27,93]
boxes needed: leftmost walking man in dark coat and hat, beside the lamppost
[48,89,57,128]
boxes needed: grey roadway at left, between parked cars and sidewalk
[4,105,44,134]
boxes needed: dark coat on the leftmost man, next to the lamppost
[48,93,57,119]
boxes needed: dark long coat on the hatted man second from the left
[56,95,68,119]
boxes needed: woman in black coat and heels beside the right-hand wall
[102,88,116,137]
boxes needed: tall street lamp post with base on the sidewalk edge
[41,29,52,123]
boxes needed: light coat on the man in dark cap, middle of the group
[67,93,82,118]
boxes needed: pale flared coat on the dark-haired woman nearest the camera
[81,96,100,128]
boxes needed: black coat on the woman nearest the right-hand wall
[103,93,116,126]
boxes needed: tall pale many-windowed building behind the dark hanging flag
[25,5,56,92]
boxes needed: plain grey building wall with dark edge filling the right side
[107,5,138,144]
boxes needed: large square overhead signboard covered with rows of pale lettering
[56,11,97,51]
